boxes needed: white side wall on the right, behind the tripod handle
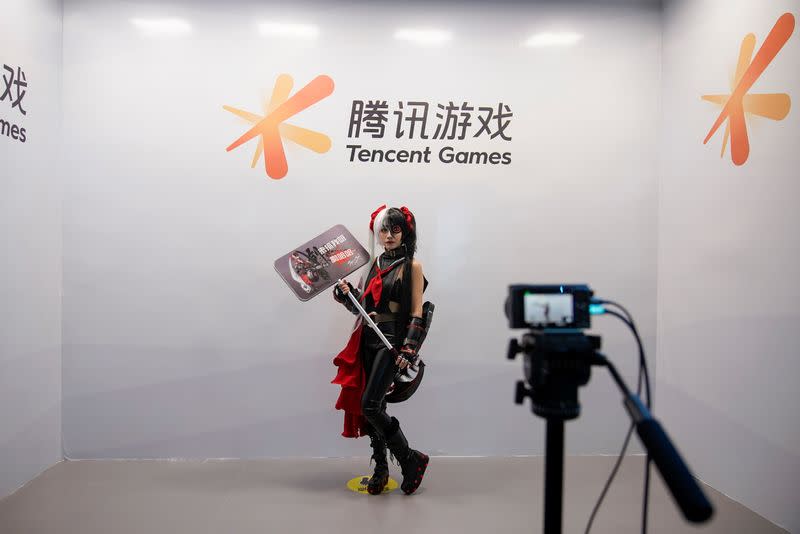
[657,0,800,532]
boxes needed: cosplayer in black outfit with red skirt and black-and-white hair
[333,206,429,495]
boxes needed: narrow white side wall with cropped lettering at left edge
[0,0,62,497]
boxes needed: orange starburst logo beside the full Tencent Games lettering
[222,74,333,180]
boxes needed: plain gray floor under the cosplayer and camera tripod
[0,456,785,534]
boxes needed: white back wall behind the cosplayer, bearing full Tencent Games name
[63,0,660,458]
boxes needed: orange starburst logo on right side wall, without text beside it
[703,13,794,165]
